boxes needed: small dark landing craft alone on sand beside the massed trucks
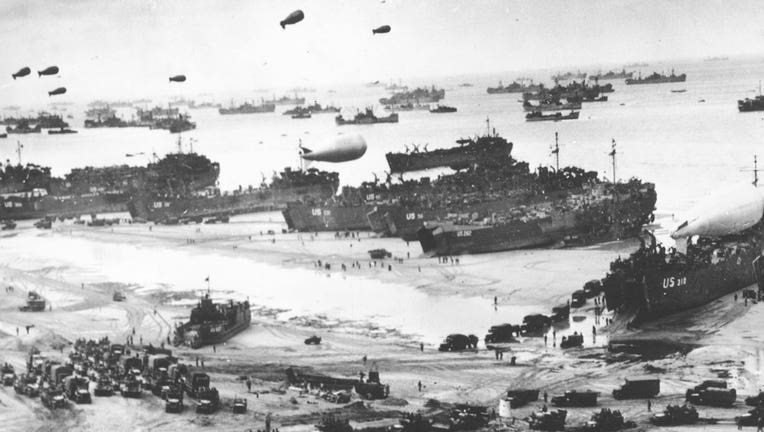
[173,293,252,349]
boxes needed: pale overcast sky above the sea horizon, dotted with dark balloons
[0,0,764,106]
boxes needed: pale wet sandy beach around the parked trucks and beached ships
[0,214,764,431]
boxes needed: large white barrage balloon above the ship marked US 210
[671,184,764,239]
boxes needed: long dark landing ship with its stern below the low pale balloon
[127,168,339,223]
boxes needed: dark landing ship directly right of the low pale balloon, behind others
[385,128,512,173]
